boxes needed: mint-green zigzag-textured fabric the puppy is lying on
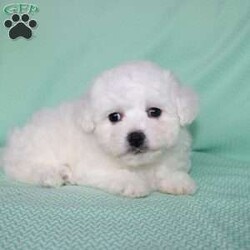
[0,153,250,250]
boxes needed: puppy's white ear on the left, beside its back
[75,95,95,133]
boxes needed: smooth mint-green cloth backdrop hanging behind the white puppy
[0,0,250,161]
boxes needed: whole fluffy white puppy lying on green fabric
[4,62,197,197]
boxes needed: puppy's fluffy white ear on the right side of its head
[166,72,198,126]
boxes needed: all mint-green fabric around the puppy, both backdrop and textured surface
[0,0,250,250]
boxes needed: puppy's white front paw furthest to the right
[158,172,196,195]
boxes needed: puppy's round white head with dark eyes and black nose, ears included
[79,62,197,166]
